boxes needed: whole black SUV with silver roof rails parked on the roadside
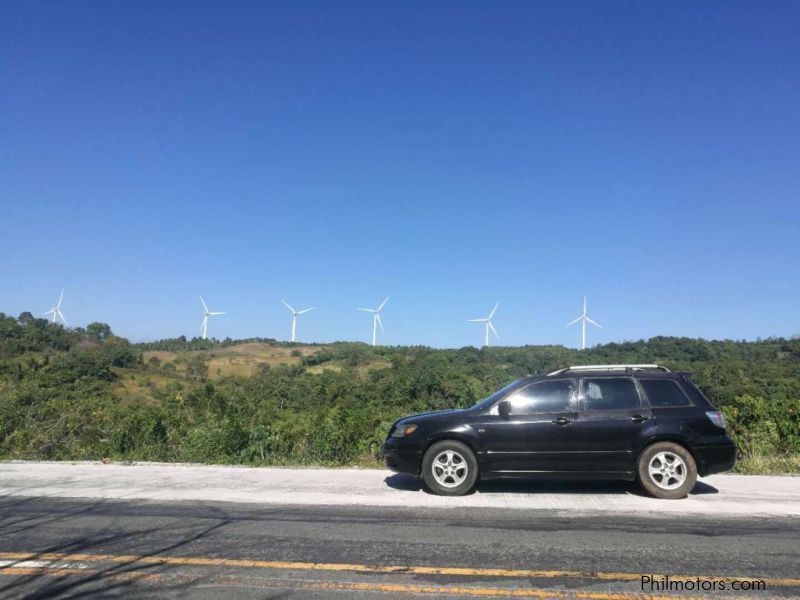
[383,365,736,498]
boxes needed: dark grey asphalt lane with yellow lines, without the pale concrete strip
[0,494,800,600]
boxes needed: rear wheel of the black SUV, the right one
[636,442,697,500]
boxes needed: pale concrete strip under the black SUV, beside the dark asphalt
[0,463,800,516]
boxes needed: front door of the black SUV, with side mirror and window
[478,379,577,474]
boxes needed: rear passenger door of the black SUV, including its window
[573,376,652,476]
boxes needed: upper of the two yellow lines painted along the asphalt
[0,552,800,587]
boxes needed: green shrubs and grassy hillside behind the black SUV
[0,313,800,472]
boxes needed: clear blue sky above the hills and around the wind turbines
[0,1,800,346]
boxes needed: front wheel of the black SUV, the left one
[422,440,478,496]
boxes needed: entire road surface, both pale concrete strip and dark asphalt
[0,463,800,600]
